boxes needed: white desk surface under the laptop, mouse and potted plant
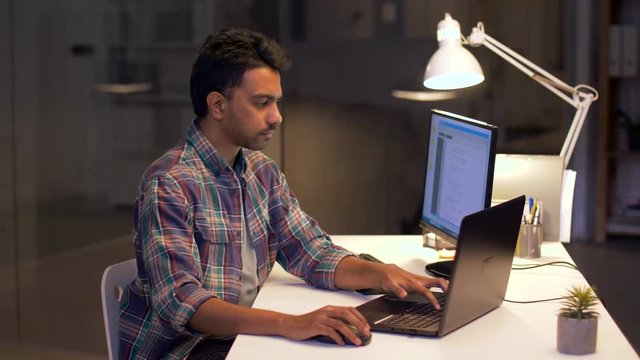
[228,236,638,360]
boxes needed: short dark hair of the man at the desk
[190,29,291,117]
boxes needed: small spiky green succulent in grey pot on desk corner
[557,286,599,355]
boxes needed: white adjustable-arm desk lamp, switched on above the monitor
[424,13,598,169]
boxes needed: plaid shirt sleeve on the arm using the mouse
[138,175,214,335]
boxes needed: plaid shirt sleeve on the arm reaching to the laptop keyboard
[269,171,354,290]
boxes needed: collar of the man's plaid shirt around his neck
[186,119,247,175]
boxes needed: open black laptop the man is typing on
[356,195,525,337]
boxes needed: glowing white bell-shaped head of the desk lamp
[424,13,484,90]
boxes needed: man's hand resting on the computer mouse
[282,306,370,345]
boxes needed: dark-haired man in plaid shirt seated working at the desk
[120,30,447,359]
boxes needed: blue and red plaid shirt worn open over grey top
[119,121,351,359]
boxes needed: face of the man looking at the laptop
[223,67,282,150]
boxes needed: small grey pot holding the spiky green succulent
[556,315,598,355]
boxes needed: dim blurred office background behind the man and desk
[0,0,640,359]
